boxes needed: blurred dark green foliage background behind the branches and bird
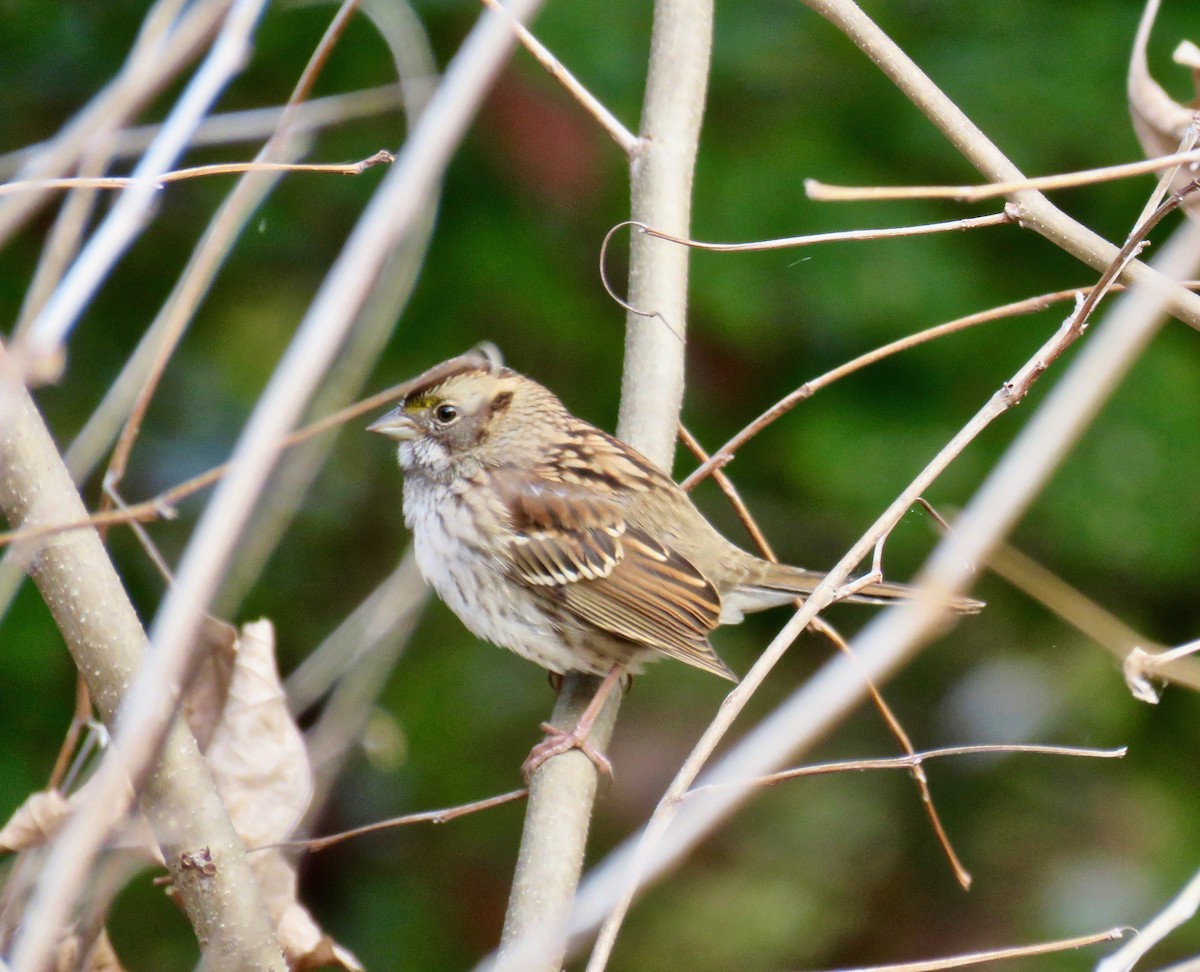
[0,0,1200,972]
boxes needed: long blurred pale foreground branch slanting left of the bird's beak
[7,0,538,972]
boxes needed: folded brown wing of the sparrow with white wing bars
[496,473,737,680]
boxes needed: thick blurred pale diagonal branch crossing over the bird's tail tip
[571,210,1200,960]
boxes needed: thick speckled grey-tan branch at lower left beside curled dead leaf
[0,348,286,970]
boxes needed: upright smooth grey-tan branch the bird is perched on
[499,0,713,972]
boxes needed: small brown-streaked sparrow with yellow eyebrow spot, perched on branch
[367,348,983,779]
